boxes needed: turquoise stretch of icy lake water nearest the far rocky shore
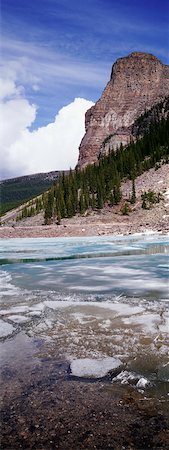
[0,236,169,298]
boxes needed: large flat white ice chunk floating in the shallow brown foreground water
[70,357,122,378]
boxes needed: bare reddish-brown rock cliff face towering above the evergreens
[78,52,169,167]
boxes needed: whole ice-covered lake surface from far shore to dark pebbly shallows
[0,234,169,394]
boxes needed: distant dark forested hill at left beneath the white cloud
[0,171,60,214]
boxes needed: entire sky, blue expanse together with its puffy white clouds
[0,0,169,179]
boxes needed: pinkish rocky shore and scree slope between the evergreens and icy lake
[0,164,169,238]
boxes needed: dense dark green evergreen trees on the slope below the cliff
[44,116,169,224]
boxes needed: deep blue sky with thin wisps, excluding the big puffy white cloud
[1,0,169,178]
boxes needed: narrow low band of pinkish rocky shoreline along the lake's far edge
[0,203,169,239]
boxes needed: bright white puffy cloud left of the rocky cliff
[1,81,93,178]
